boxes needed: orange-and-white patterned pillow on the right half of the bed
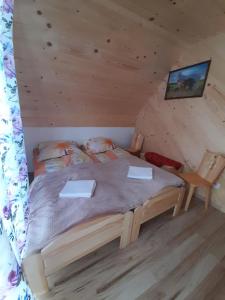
[83,137,115,153]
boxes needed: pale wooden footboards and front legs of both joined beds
[23,187,184,299]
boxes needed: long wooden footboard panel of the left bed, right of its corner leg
[41,212,125,275]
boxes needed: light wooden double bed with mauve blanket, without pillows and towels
[23,139,184,297]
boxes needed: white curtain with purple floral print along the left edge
[0,0,32,300]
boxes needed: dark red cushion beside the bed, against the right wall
[145,152,183,170]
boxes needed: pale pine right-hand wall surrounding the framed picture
[136,29,225,212]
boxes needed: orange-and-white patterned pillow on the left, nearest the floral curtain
[37,141,81,162]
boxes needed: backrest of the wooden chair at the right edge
[197,150,225,183]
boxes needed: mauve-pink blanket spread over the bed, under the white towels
[26,155,183,255]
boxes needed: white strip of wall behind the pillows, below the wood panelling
[24,127,134,172]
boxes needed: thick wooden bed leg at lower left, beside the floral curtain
[23,253,48,299]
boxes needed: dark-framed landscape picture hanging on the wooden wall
[165,60,211,100]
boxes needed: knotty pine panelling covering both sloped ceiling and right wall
[14,0,225,211]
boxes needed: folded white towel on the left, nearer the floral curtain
[59,180,96,198]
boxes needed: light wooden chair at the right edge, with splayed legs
[179,150,225,211]
